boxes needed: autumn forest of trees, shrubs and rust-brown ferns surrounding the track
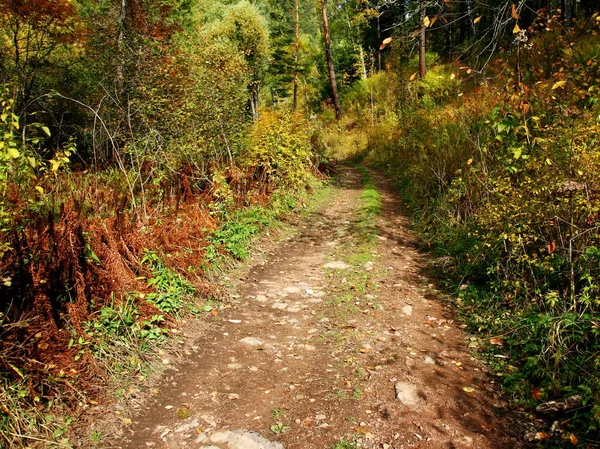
[0,0,600,447]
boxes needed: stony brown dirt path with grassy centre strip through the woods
[112,169,517,449]
